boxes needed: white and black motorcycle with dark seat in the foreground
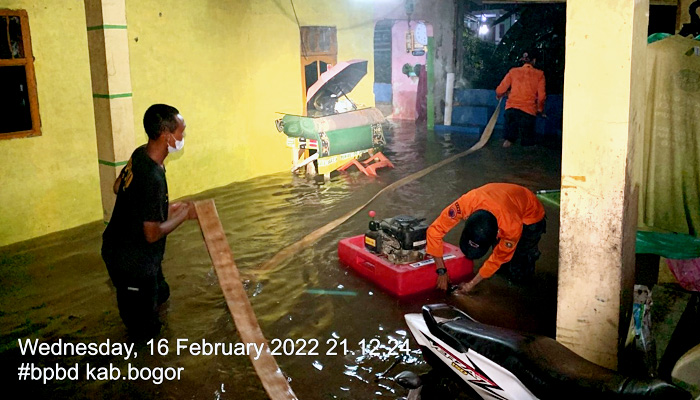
[395,304,692,400]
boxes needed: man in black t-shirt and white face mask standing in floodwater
[102,104,197,337]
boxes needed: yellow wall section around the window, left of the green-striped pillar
[0,0,102,245]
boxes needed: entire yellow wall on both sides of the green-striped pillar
[0,0,374,246]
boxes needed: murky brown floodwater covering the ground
[0,123,561,400]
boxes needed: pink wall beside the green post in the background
[391,20,433,120]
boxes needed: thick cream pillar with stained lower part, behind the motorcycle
[556,0,649,369]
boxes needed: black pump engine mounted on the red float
[365,215,428,264]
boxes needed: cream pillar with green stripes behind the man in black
[85,0,135,221]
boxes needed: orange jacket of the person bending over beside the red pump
[426,183,544,278]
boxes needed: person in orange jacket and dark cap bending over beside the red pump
[426,183,546,293]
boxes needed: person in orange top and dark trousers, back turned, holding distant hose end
[496,52,547,147]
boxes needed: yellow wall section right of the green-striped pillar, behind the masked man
[127,0,373,198]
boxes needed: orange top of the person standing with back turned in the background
[496,64,547,115]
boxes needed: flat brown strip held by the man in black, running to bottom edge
[194,200,297,400]
